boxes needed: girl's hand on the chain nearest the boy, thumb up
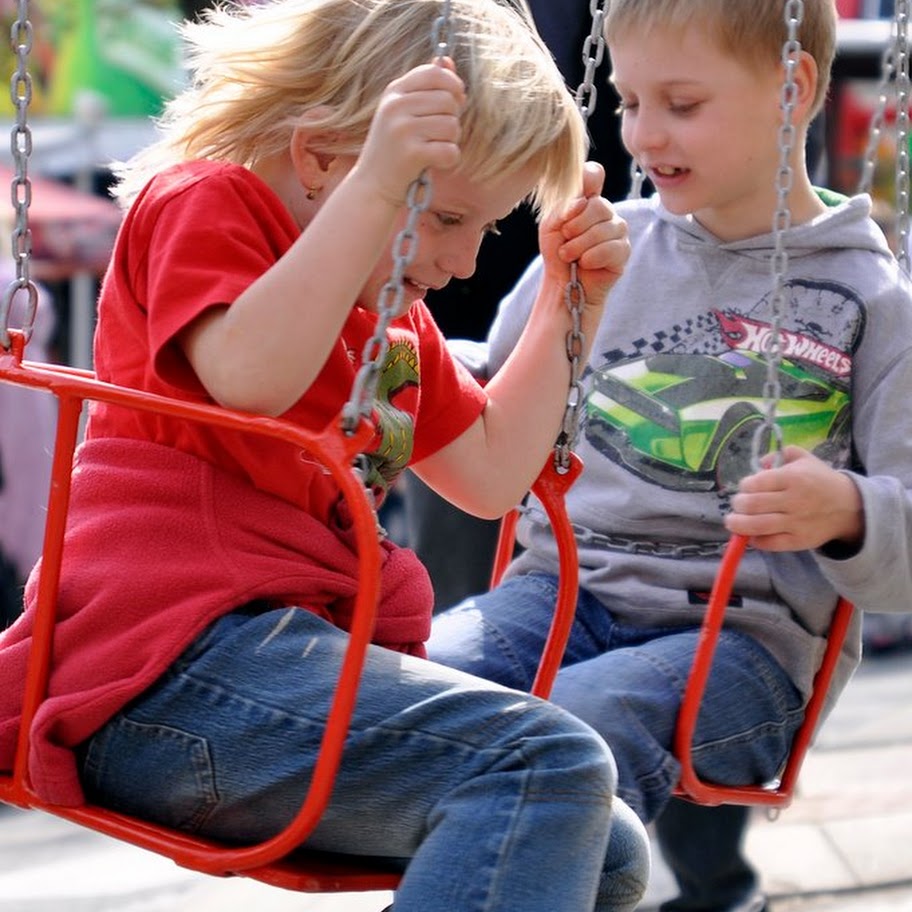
[539,162,630,306]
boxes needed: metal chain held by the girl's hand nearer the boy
[554,0,609,475]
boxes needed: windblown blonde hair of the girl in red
[115,0,586,211]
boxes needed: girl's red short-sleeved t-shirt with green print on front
[87,162,485,521]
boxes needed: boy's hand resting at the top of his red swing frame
[725,446,864,551]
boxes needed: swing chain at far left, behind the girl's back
[0,0,38,350]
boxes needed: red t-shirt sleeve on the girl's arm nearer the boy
[412,302,487,462]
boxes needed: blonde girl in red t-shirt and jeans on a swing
[0,0,646,912]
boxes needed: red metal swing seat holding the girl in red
[0,330,581,893]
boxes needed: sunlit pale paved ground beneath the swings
[0,651,912,912]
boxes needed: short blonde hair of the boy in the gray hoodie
[605,0,838,119]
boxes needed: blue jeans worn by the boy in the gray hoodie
[428,573,803,821]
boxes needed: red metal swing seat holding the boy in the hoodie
[491,478,854,807]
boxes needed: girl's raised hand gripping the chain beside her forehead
[356,58,465,207]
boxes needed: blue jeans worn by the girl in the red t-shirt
[81,606,648,912]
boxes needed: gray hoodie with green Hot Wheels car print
[478,194,912,708]
